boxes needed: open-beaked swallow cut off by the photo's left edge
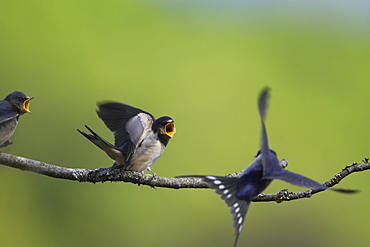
[0,91,33,148]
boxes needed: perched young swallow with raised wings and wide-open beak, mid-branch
[78,103,176,175]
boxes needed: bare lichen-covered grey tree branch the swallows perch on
[0,152,370,202]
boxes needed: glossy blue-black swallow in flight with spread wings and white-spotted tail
[180,88,355,247]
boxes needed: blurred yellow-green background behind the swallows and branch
[0,0,370,247]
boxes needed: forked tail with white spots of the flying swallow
[177,175,250,247]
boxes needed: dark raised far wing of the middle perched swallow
[97,102,155,147]
